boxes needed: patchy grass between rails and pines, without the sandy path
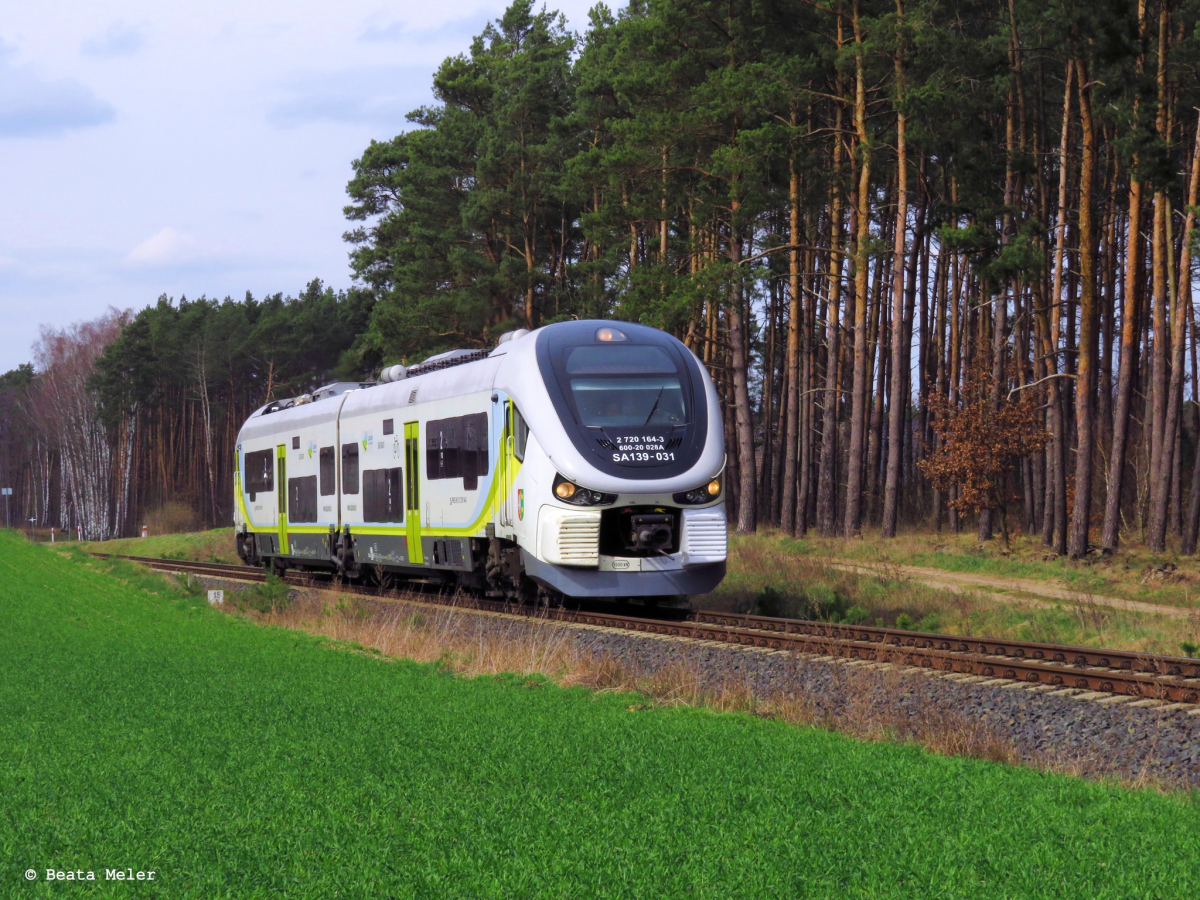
[79,528,1200,655]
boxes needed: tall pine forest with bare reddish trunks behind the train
[0,0,1200,558]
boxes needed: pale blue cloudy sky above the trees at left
[0,0,604,372]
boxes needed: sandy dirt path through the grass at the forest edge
[828,559,1200,618]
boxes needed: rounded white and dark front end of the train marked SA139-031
[494,322,727,596]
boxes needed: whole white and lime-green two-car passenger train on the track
[234,320,727,602]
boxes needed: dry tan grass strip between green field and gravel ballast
[220,592,1019,763]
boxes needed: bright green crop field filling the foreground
[0,535,1200,898]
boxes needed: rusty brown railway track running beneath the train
[108,557,1200,703]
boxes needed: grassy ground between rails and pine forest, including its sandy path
[83,528,1200,656]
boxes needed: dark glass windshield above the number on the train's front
[565,344,688,428]
